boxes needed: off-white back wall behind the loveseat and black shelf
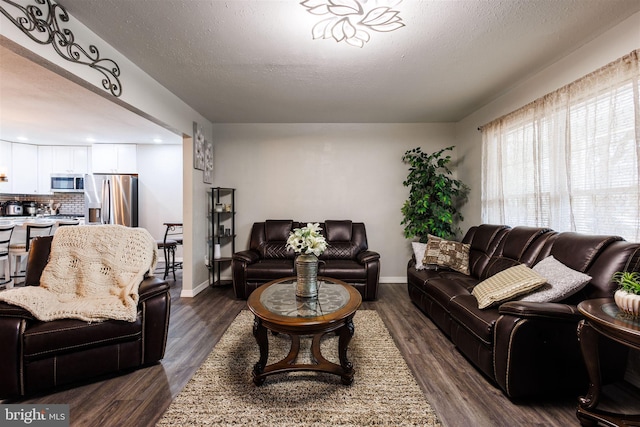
[213,123,454,282]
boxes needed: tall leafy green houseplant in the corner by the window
[401,146,469,242]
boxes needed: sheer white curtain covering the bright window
[481,50,640,242]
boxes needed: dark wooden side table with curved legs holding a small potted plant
[576,298,640,426]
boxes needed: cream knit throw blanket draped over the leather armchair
[0,225,158,322]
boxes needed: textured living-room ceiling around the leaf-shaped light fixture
[0,0,640,145]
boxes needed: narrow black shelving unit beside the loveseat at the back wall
[207,187,236,286]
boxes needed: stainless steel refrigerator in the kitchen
[84,174,138,227]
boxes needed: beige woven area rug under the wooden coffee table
[157,310,440,427]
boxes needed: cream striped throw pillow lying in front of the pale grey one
[471,264,547,309]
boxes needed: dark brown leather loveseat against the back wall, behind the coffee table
[232,220,380,300]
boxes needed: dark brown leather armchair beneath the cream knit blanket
[0,236,171,399]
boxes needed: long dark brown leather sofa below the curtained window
[407,224,640,399]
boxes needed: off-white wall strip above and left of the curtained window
[456,13,640,229]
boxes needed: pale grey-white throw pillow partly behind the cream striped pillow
[520,255,591,302]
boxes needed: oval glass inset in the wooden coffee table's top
[260,280,349,317]
